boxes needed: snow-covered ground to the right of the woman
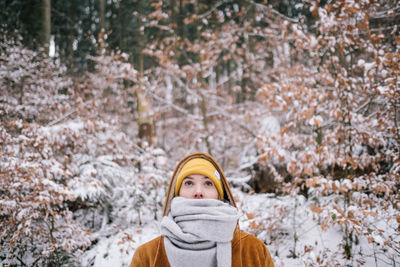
[233,189,393,267]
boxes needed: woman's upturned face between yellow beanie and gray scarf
[179,174,218,199]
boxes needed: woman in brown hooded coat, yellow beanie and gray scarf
[130,153,274,267]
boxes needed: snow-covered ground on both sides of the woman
[81,188,392,267]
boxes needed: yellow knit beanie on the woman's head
[175,158,224,199]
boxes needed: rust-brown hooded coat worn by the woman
[130,153,274,267]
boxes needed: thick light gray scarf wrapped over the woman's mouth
[161,197,238,267]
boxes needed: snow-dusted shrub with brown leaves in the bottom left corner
[0,120,90,266]
